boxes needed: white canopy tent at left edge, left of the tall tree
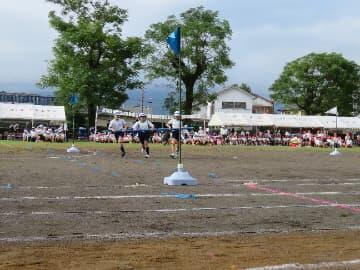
[0,103,66,122]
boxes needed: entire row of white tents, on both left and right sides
[0,103,360,130]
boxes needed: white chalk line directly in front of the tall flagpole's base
[0,191,360,201]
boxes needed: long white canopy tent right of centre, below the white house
[209,112,360,129]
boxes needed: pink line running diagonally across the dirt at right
[244,183,360,214]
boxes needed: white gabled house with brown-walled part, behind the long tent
[198,84,274,119]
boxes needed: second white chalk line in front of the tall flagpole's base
[0,204,360,216]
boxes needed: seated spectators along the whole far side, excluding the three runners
[1,123,360,147]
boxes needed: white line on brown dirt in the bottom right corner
[246,259,360,270]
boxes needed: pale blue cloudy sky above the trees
[0,0,360,100]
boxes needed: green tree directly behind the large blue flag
[145,7,234,114]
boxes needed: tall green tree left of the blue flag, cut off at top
[39,0,146,126]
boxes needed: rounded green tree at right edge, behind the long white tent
[270,53,360,115]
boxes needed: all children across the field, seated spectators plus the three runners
[16,114,360,151]
